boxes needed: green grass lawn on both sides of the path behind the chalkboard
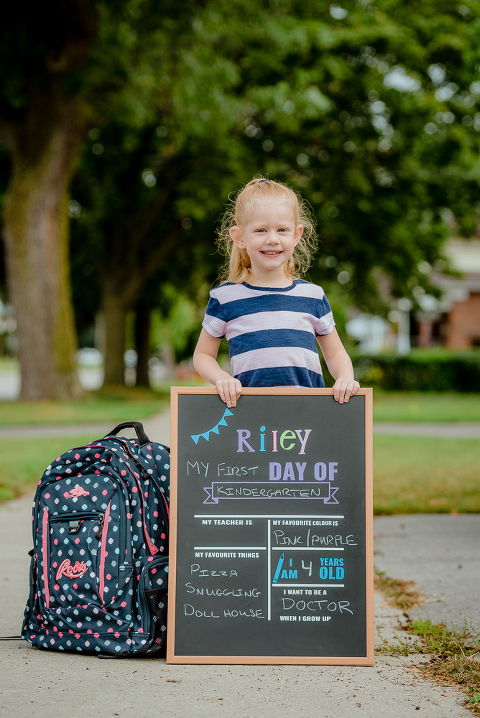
[0,386,480,514]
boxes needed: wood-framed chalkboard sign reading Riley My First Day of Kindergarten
[167,387,373,665]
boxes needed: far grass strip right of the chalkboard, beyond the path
[373,390,480,421]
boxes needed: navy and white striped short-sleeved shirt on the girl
[203,279,335,387]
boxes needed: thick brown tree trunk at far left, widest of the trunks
[4,93,83,400]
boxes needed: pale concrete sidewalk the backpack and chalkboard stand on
[0,506,476,718]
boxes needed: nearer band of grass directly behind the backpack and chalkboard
[0,435,480,514]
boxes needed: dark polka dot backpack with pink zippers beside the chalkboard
[22,422,170,657]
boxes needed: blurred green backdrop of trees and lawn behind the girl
[0,0,480,513]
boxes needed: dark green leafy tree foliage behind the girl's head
[0,0,480,394]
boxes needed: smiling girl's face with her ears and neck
[230,201,303,287]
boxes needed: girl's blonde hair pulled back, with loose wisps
[217,177,317,284]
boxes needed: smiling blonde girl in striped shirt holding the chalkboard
[193,179,360,407]
